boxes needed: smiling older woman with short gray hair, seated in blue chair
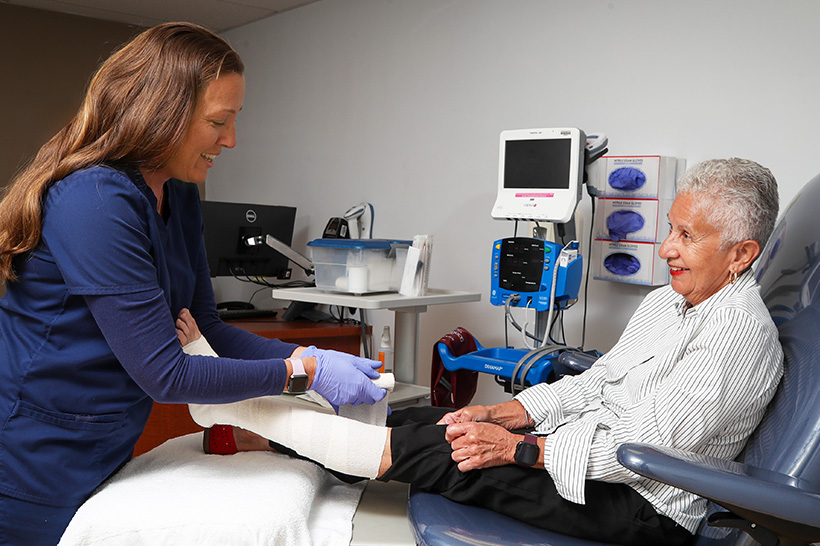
[194,159,783,546]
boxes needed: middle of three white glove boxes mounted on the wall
[594,198,672,243]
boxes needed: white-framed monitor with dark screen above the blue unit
[492,127,586,224]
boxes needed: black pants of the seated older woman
[379,408,691,546]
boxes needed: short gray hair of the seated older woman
[678,157,780,250]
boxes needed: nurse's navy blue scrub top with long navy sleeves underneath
[0,166,296,506]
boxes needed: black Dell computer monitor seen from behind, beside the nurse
[202,201,296,279]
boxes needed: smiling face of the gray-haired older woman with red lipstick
[658,193,743,306]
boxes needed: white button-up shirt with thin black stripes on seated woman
[516,271,783,533]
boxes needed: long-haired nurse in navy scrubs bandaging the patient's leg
[0,23,386,545]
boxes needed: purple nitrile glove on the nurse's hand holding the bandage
[300,345,387,413]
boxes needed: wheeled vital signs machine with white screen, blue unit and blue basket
[438,128,607,394]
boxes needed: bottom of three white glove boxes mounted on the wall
[592,240,669,286]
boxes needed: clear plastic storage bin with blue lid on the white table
[308,239,413,295]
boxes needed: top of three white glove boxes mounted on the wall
[588,155,686,199]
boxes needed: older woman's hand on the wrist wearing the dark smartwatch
[444,422,521,472]
